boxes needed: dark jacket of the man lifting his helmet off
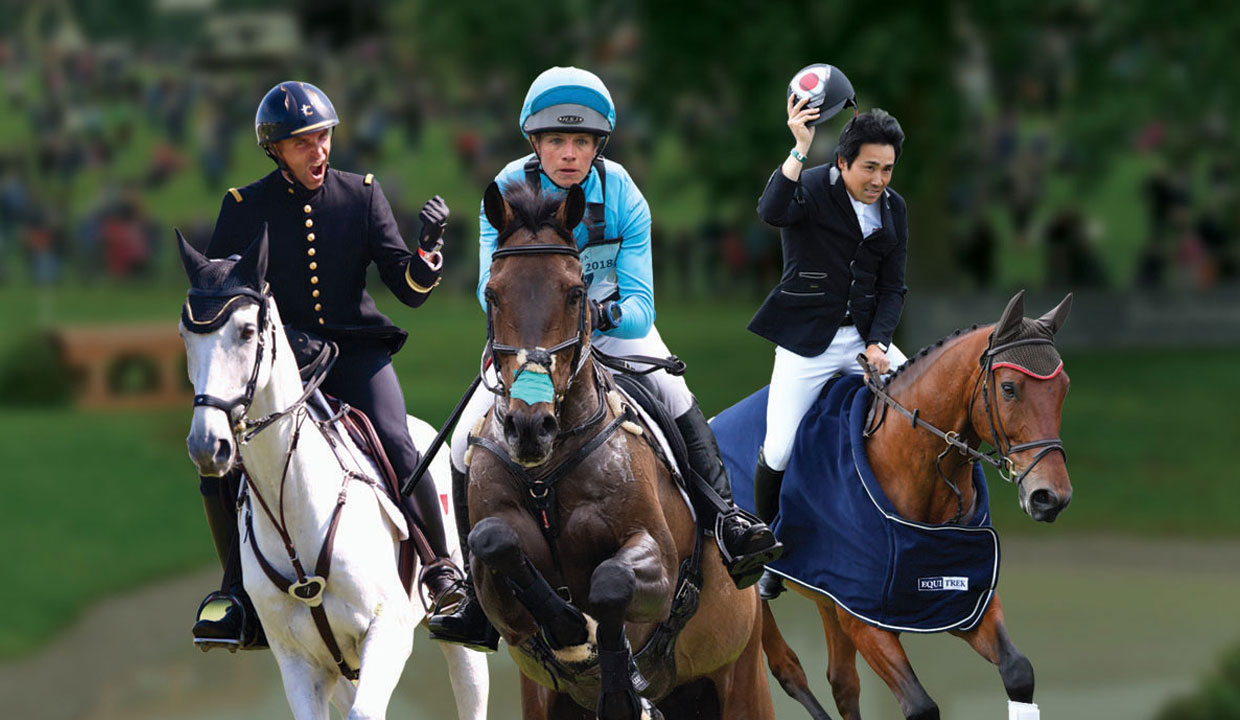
[749,165,909,357]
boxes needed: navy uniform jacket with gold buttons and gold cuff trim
[207,169,439,353]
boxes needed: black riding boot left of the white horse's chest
[193,470,267,652]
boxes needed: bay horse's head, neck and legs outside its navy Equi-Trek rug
[739,292,1073,720]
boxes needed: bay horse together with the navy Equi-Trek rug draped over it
[715,292,1073,719]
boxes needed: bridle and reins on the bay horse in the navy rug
[857,335,1068,523]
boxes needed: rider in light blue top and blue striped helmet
[429,67,781,649]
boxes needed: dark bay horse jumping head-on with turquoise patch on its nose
[466,182,774,720]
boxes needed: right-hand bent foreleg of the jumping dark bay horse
[590,532,672,720]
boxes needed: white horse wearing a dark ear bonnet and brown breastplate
[177,229,490,720]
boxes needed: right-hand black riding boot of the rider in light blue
[676,400,784,589]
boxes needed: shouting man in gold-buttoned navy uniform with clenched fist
[193,82,460,646]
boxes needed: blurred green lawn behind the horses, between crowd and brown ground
[0,288,1240,658]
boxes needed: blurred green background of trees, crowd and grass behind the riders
[0,0,1240,718]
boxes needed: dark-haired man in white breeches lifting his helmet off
[749,64,908,595]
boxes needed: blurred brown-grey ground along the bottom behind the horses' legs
[0,528,1240,720]
